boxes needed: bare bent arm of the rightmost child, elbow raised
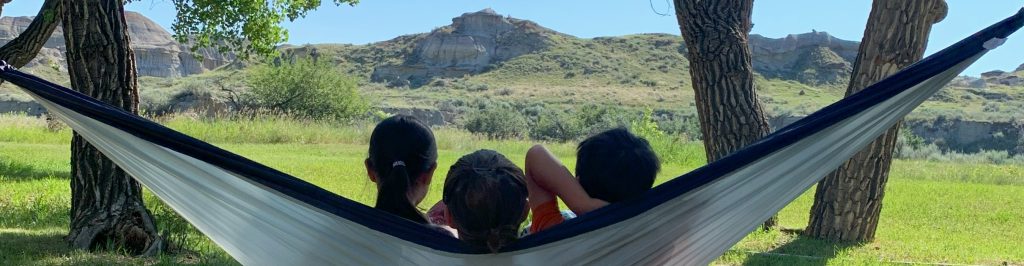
[526,145,608,214]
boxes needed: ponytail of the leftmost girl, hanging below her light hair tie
[374,161,428,224]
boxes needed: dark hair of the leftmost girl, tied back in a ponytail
[367,115,437,224]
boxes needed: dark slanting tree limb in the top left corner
[0,0,63,68]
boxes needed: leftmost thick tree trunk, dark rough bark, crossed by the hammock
[63,0,163,255]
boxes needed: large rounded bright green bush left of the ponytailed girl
[249,59,369,120]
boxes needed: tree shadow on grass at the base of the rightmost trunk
[743,229,863,265]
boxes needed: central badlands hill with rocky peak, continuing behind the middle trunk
[285,9,858,86]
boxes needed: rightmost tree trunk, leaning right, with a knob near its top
[804,0,946,241]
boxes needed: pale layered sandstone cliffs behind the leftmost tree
[0,11,234,77]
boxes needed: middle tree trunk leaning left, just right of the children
[675,0,775,228]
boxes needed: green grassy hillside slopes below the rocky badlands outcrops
[6,34,1024,124]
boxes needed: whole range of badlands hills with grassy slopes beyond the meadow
[0,9,1024,153]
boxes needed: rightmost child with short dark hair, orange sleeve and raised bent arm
[526,128,660,233]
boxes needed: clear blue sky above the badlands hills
[3,0,1024,76]
